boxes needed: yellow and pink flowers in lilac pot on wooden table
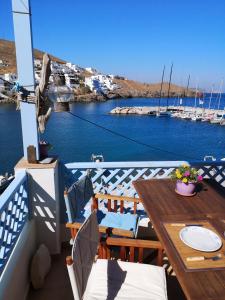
[171,164,203,196]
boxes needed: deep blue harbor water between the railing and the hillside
[0,95,225,174]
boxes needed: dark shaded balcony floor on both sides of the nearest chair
[27,241,186,300]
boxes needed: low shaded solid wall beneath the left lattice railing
[0,220,37,300]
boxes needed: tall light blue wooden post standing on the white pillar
[12,0,39,160]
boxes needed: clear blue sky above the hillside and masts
[0,0,225,88]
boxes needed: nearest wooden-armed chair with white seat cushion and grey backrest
[66,211,167,300]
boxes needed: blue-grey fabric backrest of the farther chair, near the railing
[64,175,94,223]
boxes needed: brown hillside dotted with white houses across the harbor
[0,40,192,102]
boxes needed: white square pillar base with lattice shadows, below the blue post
[27,163,61,254]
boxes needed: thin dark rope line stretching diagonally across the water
[68,112,200,160]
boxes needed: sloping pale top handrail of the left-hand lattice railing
[0,171,27,213]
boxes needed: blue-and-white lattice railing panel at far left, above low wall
[0,171,28,275]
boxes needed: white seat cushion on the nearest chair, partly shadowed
[83,259,167,300]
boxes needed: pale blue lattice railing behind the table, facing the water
[65,161,225,197]
